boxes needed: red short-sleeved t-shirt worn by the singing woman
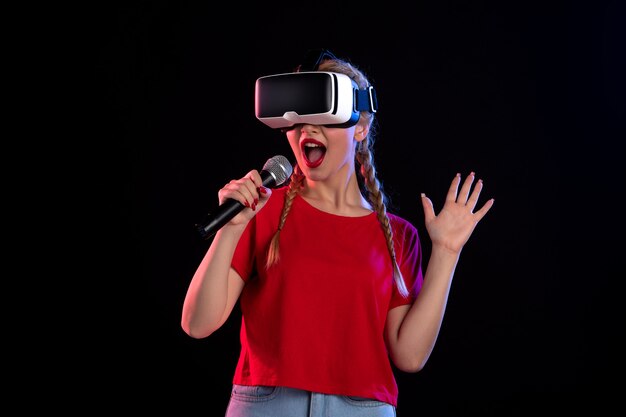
[232,187,423,406]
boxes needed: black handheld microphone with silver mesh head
[196,155,293,239]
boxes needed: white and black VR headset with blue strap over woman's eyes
[254,71,378,129]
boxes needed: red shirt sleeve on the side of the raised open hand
[389,218,424,309]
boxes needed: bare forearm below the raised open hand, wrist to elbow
[394,246,460,371]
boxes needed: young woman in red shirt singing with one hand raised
[182,53,493,417]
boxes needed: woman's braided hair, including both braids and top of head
[267,58,409,297]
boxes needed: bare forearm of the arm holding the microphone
[181,225,244,338]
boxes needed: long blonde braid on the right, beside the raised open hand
[356,135,409,297]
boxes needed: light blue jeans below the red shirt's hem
[226,384,396,417]
